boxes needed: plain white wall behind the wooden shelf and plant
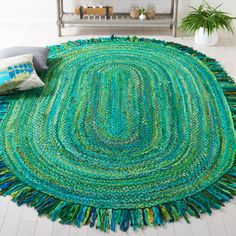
[0,0,236,26]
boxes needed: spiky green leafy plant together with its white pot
[180,1,235,46]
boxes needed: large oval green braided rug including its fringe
[0,36,236,231]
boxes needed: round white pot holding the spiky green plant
[195,28,218,46]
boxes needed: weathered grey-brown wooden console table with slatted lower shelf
[57,0,178,37]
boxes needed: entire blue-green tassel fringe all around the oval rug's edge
[0,35,236,232]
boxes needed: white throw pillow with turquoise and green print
[0,54,44,95]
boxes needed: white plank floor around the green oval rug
[0,23,236,236]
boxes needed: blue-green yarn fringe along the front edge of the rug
[0,157,236,232]
